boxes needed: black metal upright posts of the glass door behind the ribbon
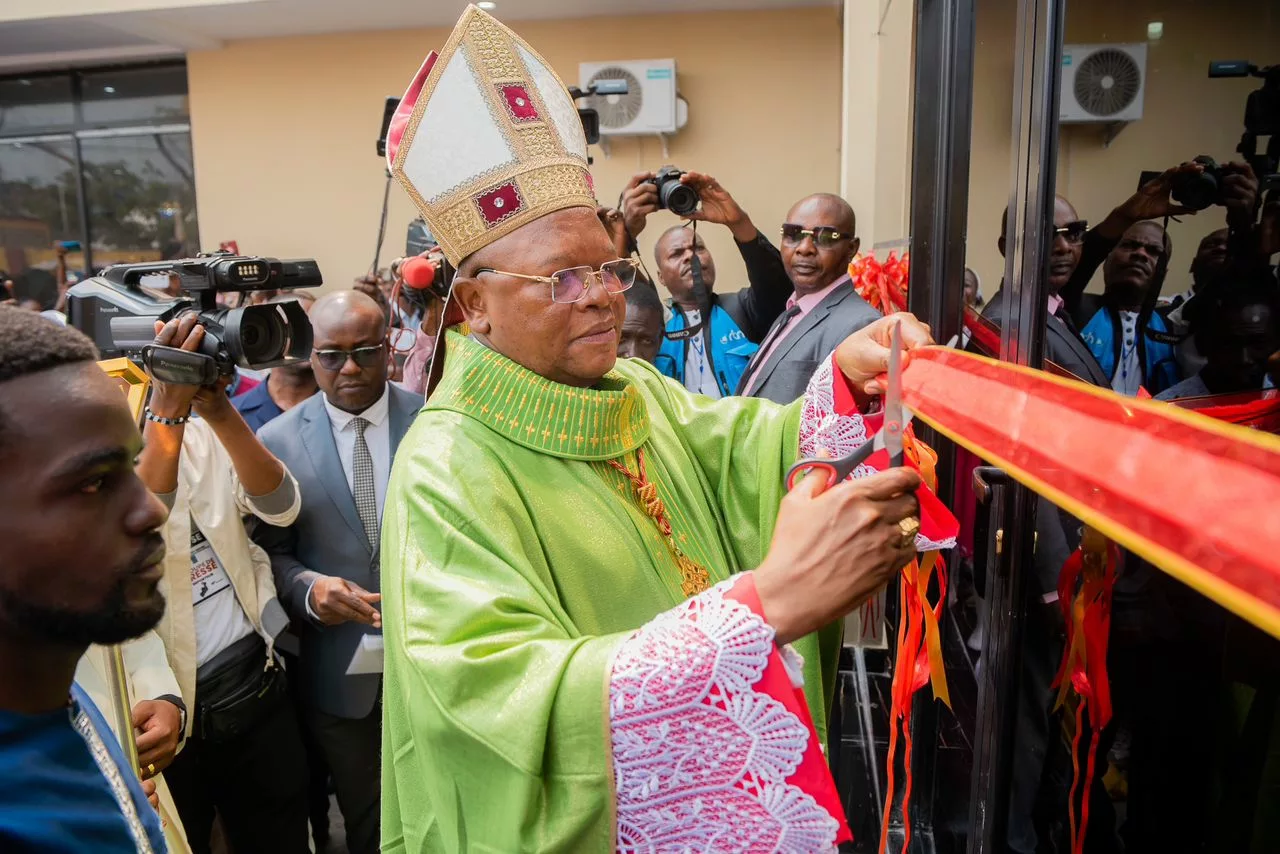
[891,0,1066,854]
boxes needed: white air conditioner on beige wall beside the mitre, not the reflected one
[577,59,687,136]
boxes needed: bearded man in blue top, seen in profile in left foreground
[0,306,165,854]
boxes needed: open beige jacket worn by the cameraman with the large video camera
[156,419,302,736]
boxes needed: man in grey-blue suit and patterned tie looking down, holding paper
[255,291,422,854]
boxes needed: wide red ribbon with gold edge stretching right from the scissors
[902,347,1280,636]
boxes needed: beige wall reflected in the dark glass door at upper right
[969,0,1280,298]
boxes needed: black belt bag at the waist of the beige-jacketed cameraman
[195,634,288,743]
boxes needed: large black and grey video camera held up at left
[67,252,324,385]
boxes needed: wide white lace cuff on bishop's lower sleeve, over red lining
[609,576,841,854]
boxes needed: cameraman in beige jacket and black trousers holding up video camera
[138,312,308,854]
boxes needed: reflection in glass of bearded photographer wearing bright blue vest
[1082,220,1180,397]
